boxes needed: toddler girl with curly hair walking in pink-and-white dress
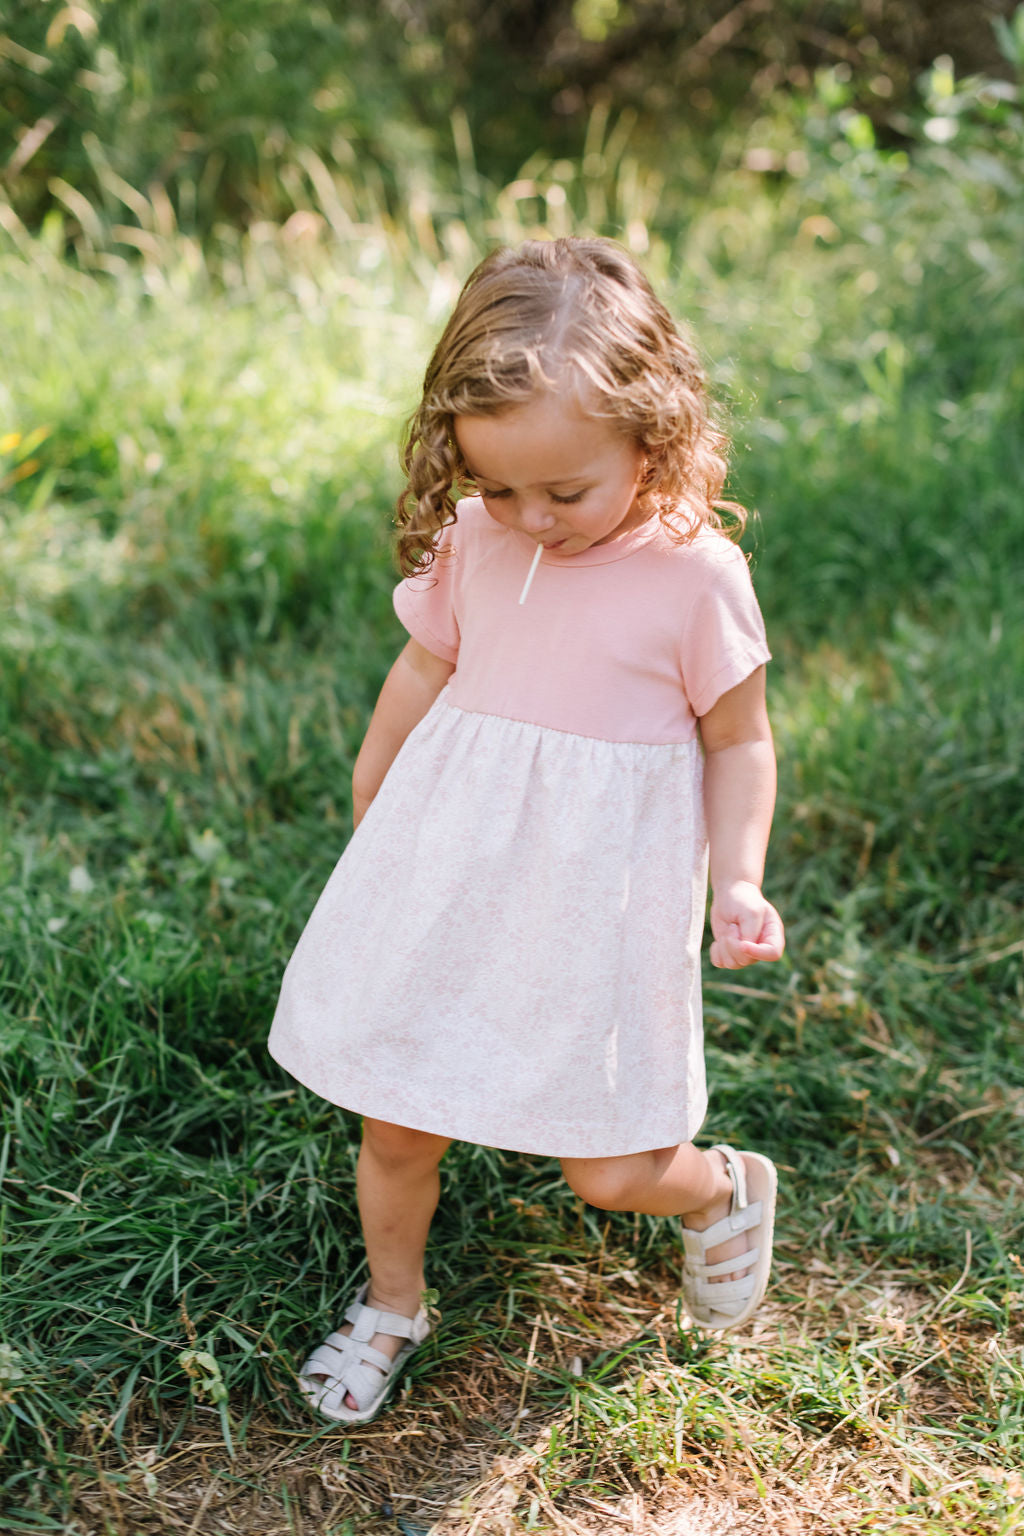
[270,240,783,1424]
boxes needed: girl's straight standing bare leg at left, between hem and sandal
[313,1120,451,1409]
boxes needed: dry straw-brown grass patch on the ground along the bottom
[56,1241,1024,1536]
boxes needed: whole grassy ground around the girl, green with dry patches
[0,92,1024,1536]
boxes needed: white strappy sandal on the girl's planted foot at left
[298,1281,430,1424]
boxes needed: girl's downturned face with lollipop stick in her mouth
[454,392,648,554]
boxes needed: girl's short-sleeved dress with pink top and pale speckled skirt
[270,499,769,1157]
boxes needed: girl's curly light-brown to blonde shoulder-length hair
[395,238,746,576]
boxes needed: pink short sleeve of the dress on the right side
[680,535,771,716]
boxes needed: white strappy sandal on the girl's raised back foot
[683,1144,778,1329]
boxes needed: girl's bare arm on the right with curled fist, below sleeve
[700,667,786,971]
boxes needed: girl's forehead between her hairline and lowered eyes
[454,392,631,485]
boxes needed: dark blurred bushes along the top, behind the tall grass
[0,0,1019,238]
